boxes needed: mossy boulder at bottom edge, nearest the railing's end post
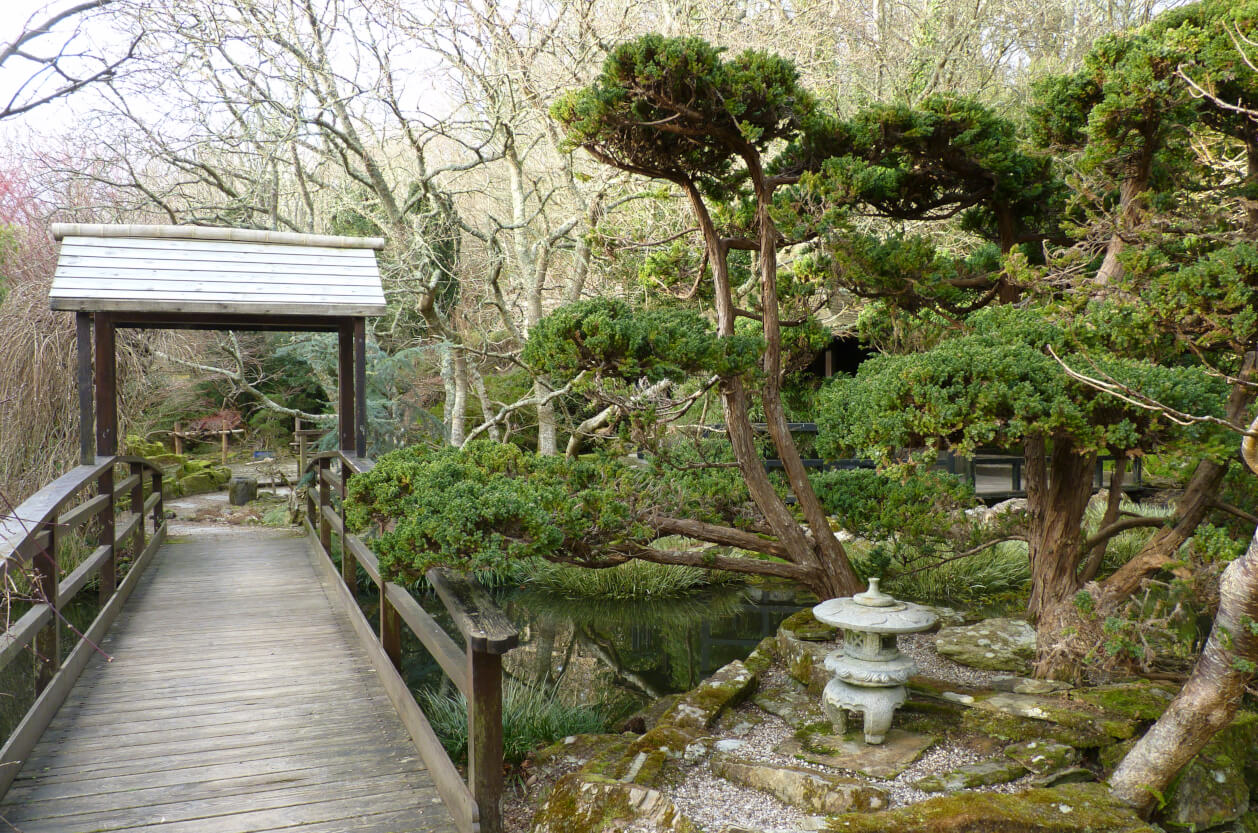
[532,773,699,833]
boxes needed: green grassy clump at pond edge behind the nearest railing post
[423,679,611,764]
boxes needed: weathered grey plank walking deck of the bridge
[0,531,454,833]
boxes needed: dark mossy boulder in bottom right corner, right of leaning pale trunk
[1160,712,1258,830]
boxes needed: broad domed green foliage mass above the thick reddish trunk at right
[818,306,1223,458]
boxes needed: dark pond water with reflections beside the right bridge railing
[403,588,800,712]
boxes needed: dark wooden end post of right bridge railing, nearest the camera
[468,646,502,833]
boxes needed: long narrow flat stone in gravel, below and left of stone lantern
[711,752,888,814]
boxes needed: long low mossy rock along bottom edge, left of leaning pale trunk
[823,784,1156,833]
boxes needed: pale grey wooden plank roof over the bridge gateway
[49,223,385,318]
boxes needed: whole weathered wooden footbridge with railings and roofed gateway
[0,226,517,833]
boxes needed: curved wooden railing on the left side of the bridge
[0,457,166,795]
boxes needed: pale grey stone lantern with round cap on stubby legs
[813,579,938,744]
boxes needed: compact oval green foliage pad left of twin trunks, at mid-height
[521,298,759,384]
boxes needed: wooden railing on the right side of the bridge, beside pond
[306,452,517,833]
